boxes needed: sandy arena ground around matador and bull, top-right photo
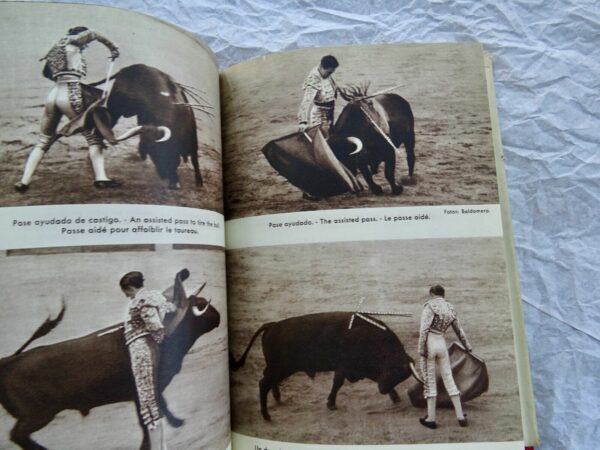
[221,45,498,219]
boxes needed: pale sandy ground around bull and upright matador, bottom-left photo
[0,250,230,450]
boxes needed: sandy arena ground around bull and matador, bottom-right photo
[227,238,522,445]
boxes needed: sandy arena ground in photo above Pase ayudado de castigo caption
[0,4,223,212]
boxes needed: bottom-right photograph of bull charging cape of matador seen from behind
[227,238,523,445]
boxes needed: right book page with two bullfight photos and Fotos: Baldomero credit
[221,44,535,450]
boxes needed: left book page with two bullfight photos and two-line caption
[0,2,230,449]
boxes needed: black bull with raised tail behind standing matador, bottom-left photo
[0,296,220,450]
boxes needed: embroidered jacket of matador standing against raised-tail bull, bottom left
[125,288,176,345]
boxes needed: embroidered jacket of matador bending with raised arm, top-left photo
[41,30,119,80]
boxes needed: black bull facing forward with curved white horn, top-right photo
[327,87,415,195]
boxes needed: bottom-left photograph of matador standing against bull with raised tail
[0,246,230,450]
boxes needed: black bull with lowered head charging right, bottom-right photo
[230,312,417,420]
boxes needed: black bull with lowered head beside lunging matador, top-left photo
[61,64,202,188]
